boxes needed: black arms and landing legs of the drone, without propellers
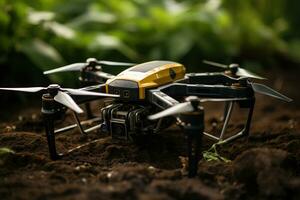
[42,71,255,177]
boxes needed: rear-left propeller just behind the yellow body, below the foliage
[44,58,135,74]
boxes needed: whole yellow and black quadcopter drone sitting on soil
[0,58,292,177]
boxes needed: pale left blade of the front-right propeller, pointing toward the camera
[148,102,194,120]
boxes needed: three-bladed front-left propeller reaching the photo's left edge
[0,84,120,113]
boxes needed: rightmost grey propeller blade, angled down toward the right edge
[251,83,293,102]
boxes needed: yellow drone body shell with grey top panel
[106,61,185,100]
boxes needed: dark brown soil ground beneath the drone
[0,69,300,200]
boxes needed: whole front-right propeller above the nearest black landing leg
[148,96,247,120]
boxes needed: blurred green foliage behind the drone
[0,0,300,86]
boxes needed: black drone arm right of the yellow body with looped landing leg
[148,73,255,144]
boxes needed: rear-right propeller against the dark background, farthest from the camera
[203,60,266,79]
